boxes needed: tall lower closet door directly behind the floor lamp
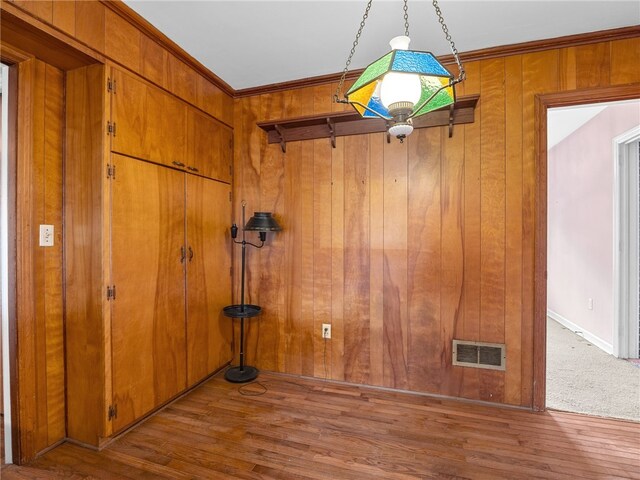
[187,175,232,385]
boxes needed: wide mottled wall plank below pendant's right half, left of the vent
[407,128,442,392]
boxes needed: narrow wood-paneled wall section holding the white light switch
[13,59,65,460]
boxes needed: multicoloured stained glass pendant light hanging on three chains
[334,0,465,142]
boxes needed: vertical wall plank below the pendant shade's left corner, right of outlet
[344,135,370,383]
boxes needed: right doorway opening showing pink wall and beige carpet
[546,100,640,420]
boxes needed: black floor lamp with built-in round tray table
[222,201,282,383]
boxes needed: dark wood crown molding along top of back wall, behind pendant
[234,25,640,98]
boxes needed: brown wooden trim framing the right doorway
[532,84,640,411]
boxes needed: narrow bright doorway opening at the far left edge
[0,63,13,465]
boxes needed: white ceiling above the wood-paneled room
[124,0,640,90]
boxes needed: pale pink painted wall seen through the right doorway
[547,103,640,345]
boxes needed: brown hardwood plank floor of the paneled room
[2,374,640,480]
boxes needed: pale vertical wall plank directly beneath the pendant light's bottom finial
[382,134,409,389]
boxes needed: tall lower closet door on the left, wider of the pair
[111,154,186,432]
